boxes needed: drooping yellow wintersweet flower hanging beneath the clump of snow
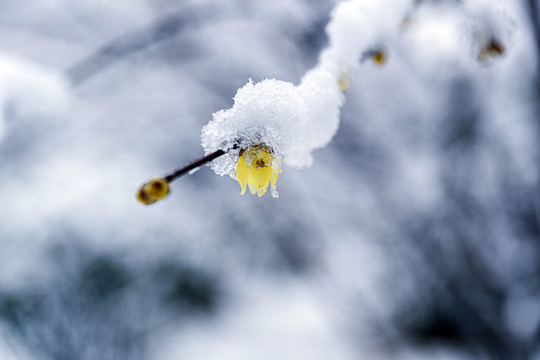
[236,145,282,197]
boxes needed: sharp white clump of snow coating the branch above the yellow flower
[201,0,408,196]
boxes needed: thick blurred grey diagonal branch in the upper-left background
[66,6,219,86]
